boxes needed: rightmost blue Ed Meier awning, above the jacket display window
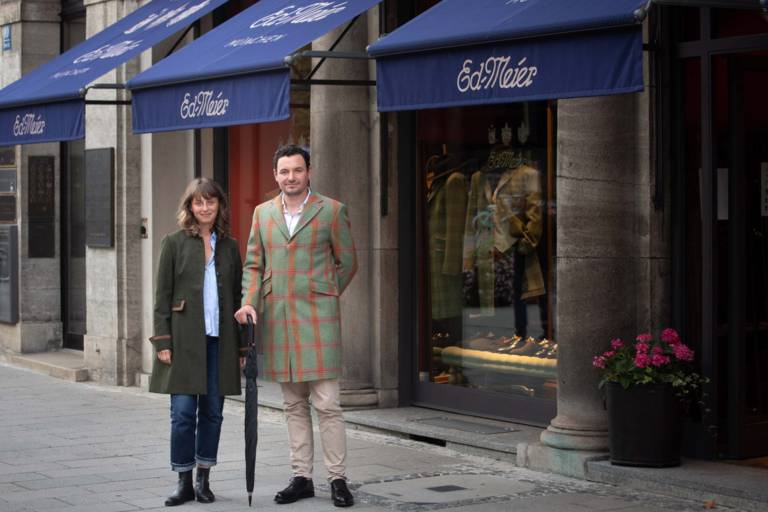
[368,0,647,112]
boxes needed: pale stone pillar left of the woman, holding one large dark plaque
[84,0,142,385]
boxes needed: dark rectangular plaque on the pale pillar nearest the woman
[85,148,115,247]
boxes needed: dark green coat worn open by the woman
[149,230,247,395]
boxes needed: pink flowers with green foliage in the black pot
[592,328,709,401]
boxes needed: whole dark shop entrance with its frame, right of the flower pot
[673,4,768,459]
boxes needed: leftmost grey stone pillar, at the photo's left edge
[0,0,62,352]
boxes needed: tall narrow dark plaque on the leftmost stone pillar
[27,156,56,258]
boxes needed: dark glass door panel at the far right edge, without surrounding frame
[714,52,768,458]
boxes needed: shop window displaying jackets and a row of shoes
[417,102,557,398]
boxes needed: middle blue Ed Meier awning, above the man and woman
[128,0,388,133]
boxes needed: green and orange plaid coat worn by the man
[242,192,357,382]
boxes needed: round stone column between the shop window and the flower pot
[518,95,652,476]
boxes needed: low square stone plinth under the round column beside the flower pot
[517,443,608,479]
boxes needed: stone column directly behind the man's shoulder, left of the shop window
[310,16,378,406]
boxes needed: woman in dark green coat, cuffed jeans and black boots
[149,178,247,506]
